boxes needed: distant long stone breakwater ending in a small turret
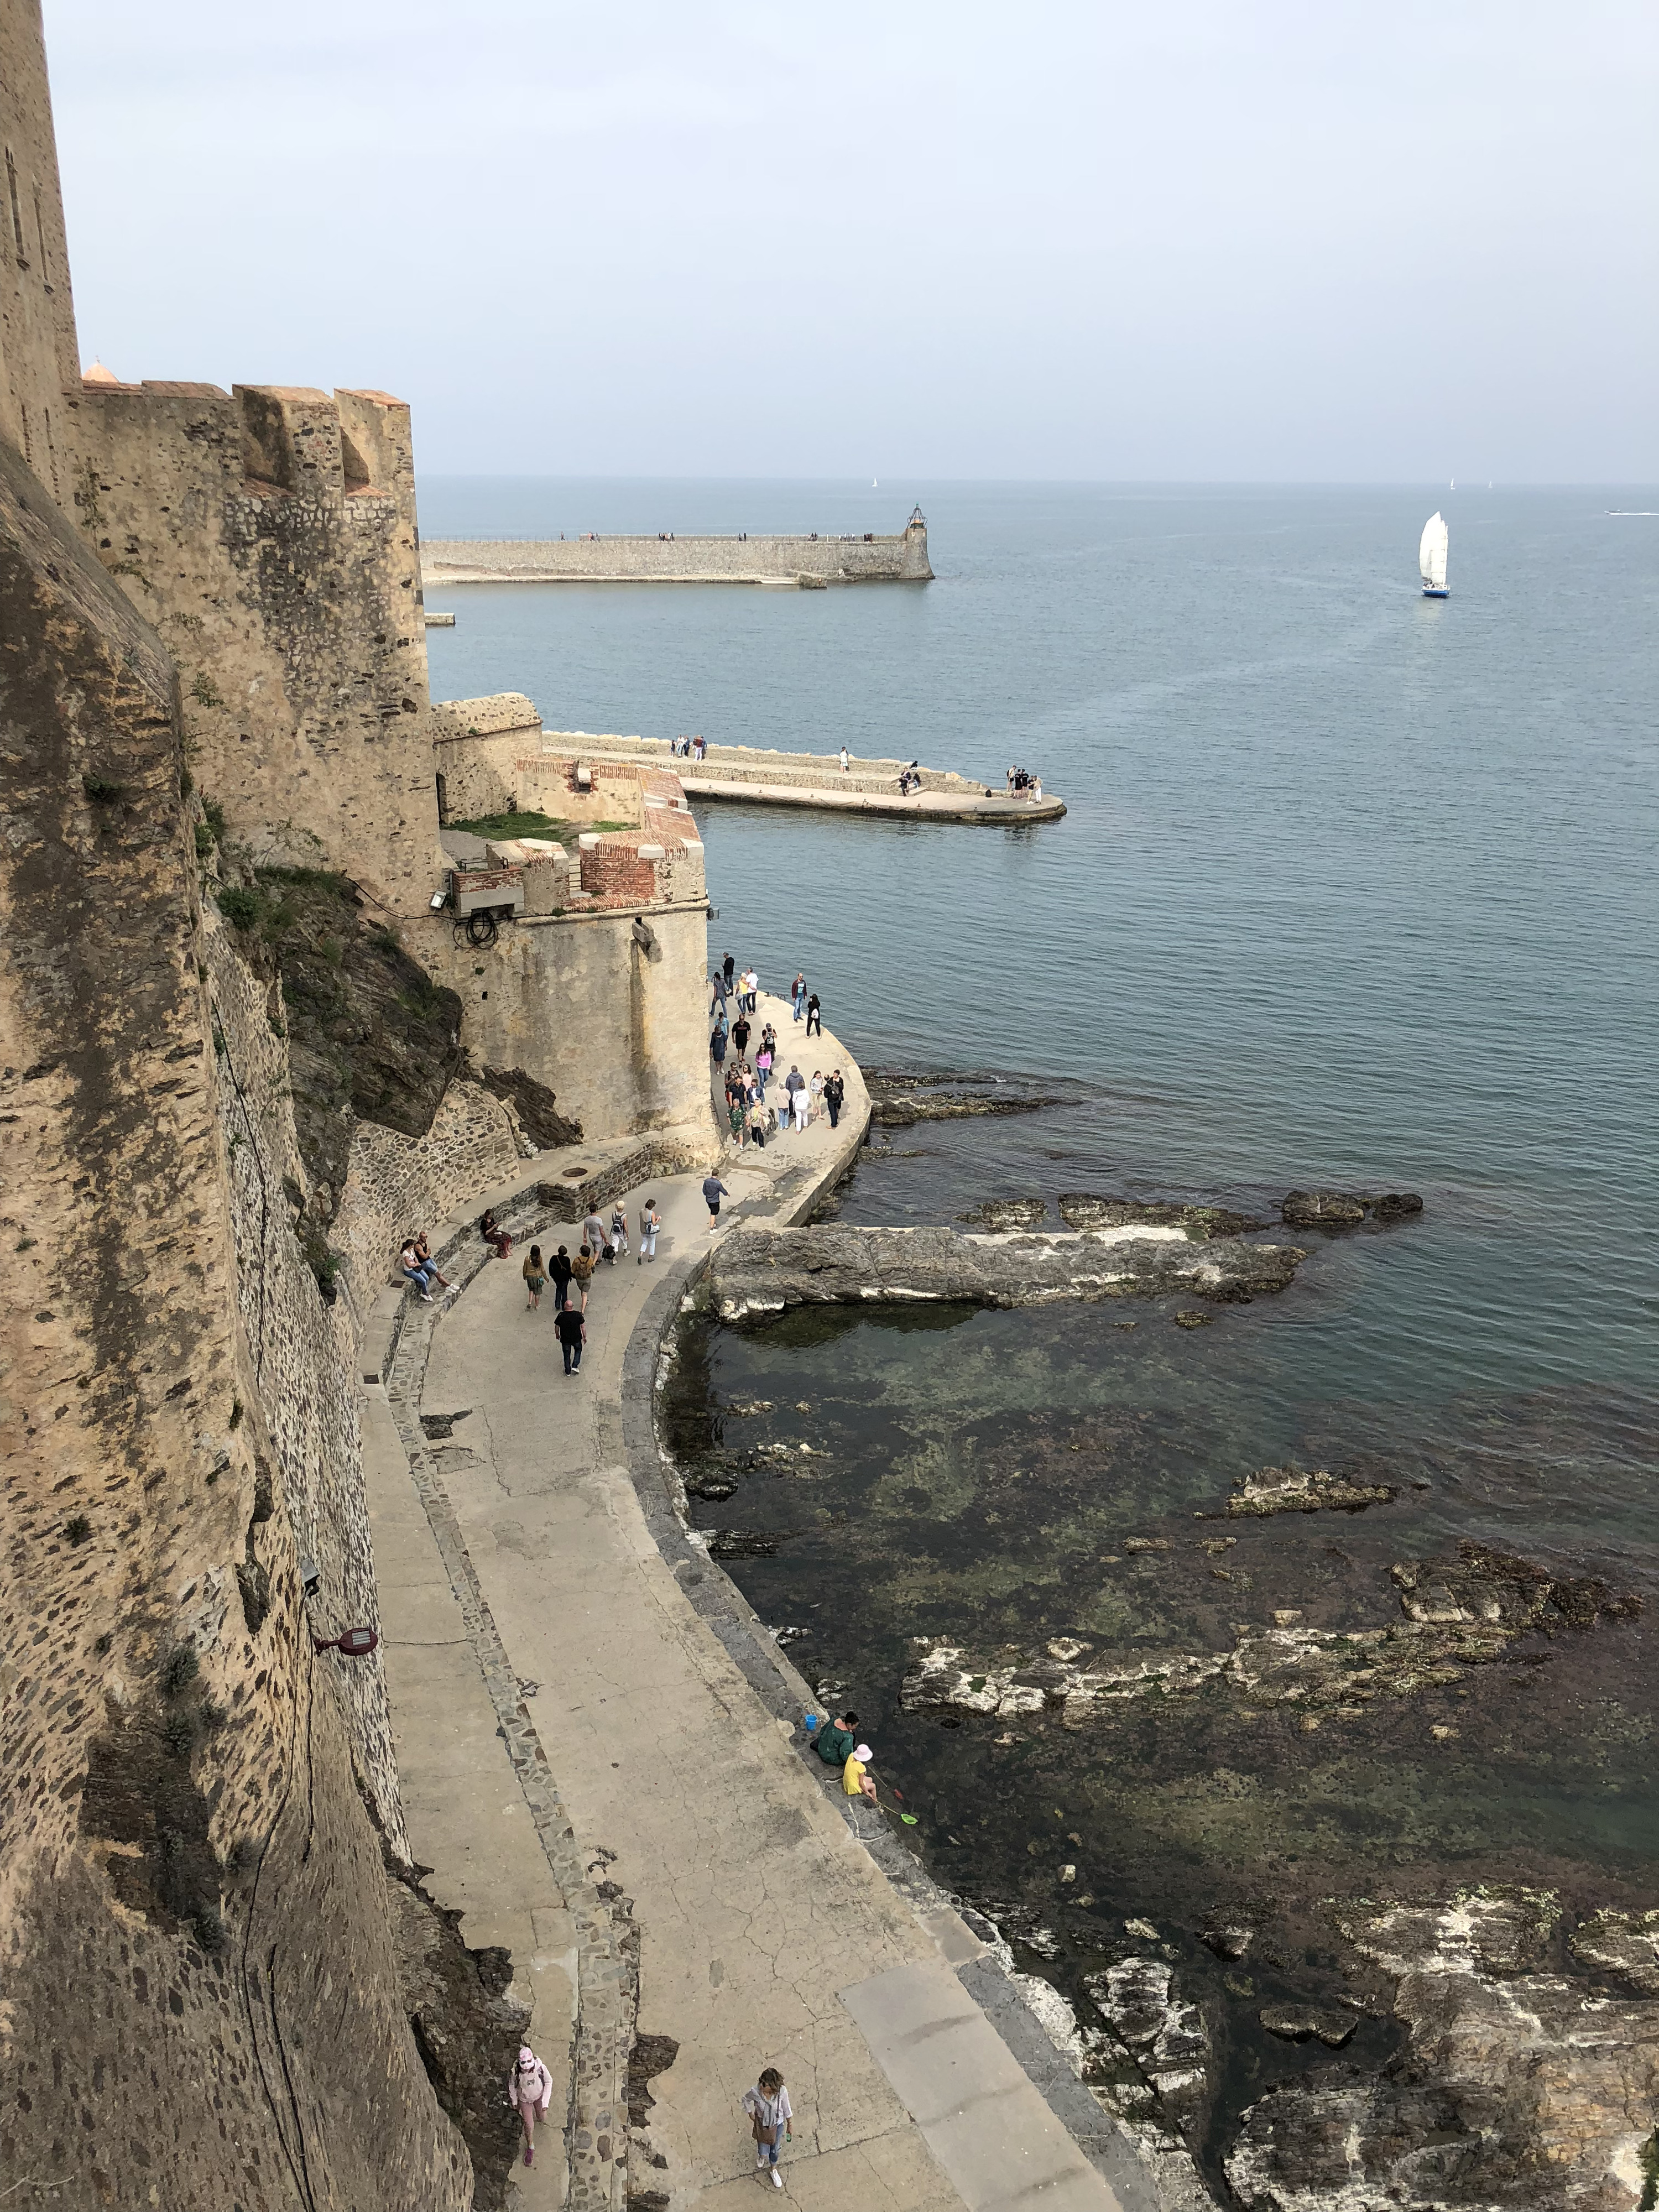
[420,509,933,584]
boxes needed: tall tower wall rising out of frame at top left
[0,0,80,502]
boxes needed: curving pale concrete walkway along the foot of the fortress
[369,1002,1150,2212]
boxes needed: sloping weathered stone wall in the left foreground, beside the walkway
[0,427,471,2212]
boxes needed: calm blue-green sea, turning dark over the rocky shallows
[422,482,1659,2148]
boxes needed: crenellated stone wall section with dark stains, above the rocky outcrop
[66,383,442,918]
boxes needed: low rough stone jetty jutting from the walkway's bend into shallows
[708,1223,1307,1323]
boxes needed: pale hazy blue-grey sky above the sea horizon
[46,0,1659,482]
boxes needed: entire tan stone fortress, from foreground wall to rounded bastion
[0,0,712,2212]
